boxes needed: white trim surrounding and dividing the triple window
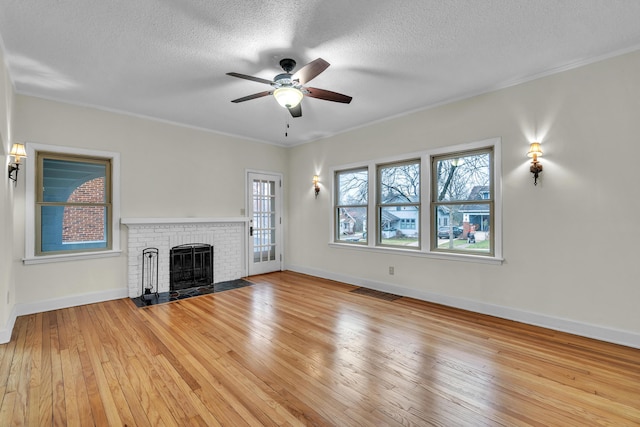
[329,137,504,264]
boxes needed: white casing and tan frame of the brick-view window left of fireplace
[23,142,121,264]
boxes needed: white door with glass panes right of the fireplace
[247,172,282,276]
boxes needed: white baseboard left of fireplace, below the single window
[0,288,129,344]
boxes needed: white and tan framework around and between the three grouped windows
[329,137,503,264]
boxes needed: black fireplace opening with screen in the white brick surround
[169,243,213,291]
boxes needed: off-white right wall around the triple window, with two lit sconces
[287,53,640,347]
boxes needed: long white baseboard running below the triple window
[286,265,640,349]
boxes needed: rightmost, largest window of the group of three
[431,148,495,255]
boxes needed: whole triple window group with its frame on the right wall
[333,138,502,263]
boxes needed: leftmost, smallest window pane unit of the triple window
[334,169,369,243]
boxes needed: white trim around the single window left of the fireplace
[22,142,122,264]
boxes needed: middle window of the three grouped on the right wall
[377,160,420,248]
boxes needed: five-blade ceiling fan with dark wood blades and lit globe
[227,58,352,117]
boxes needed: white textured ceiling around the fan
[0,0,640,145]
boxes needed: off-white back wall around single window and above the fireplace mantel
[6,95,287,324]
